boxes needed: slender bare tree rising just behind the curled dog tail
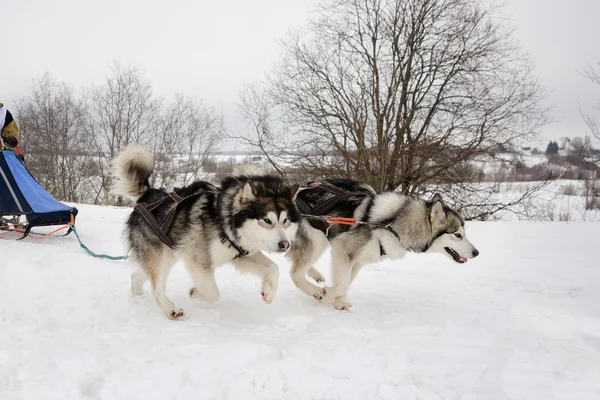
[85,63,158,203]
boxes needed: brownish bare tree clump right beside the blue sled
[18,74,90,202]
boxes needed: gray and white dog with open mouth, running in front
[288,179,479,310]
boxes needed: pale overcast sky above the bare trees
[0,0,600,150]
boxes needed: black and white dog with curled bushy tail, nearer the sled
[112,146,300,319]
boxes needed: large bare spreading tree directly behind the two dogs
[242,0,546,219]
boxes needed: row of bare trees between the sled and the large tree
[16,63,224,204]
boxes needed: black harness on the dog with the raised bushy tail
[133,192,248,258]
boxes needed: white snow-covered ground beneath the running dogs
[0,206,600,400]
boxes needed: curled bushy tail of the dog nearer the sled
[111,145,154,201]
